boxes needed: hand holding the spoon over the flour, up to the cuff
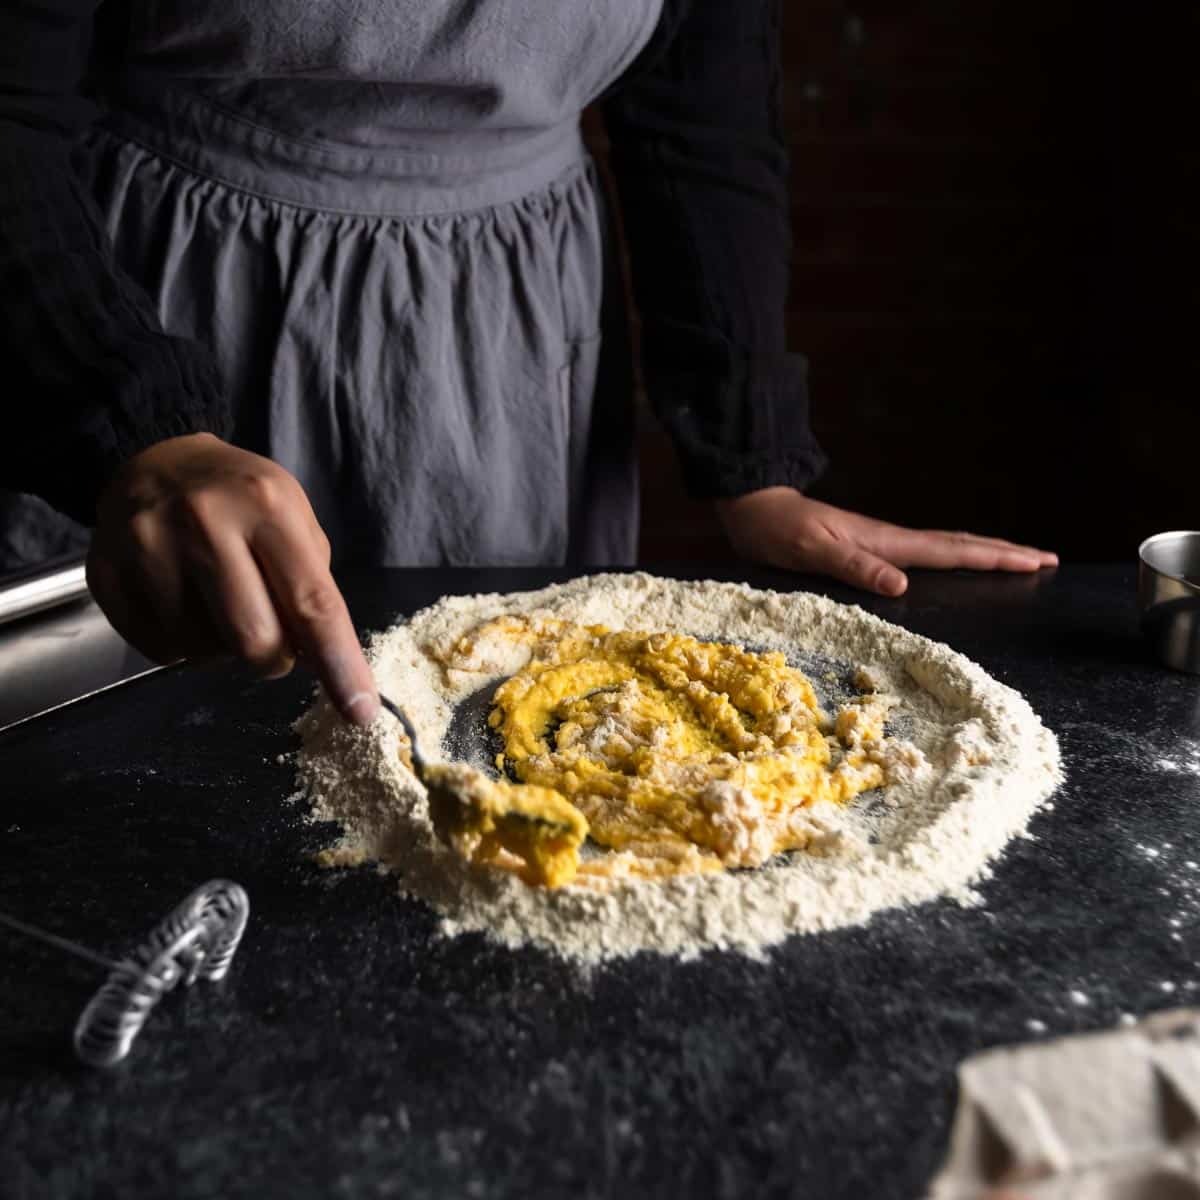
[88,433,379,725]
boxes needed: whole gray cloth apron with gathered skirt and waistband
[2,0,661,565]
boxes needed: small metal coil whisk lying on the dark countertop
[0,880,250,1067]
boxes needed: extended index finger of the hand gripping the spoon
[251,522,379,725]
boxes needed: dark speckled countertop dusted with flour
[0,566,1200,1200]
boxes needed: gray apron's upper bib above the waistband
[103,0,661,156]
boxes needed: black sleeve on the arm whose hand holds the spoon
[0,0,229,523]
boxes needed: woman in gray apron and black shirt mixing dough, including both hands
[0,0,1054,721]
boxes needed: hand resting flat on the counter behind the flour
[716,487,1058,596]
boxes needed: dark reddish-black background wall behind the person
[609,0,1200,560]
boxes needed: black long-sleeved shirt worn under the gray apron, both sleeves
[0,0,823,522]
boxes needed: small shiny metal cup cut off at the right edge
[1138,529,1200,674]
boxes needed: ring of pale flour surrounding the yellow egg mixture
[296,574,1062,962]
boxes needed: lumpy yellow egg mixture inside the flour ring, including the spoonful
[427,617,887,887]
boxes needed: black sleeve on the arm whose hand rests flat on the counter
[602,0,826,497]
